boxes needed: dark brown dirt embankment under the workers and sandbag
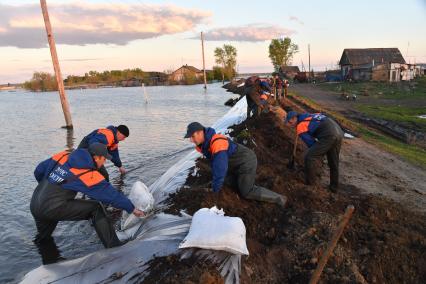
[146,83,426,283]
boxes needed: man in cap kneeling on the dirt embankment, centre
[185,122,287,207]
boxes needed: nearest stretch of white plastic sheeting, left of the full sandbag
[21,213,191,284]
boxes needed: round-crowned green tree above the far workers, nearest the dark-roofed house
[269,37,299,72]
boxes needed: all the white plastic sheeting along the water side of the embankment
[22,99,247,283]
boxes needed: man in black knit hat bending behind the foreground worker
[78,125,129,181]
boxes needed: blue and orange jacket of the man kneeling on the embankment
[196,127,237,192]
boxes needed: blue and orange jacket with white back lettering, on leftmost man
[34,149,135,213]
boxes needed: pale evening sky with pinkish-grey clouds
[0,0,426,84]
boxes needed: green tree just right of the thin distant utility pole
[214,44,237,82]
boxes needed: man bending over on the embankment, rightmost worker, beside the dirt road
[286,111,344,192]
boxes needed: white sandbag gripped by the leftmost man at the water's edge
[121,181,154,230]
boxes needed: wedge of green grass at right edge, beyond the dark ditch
[355,104,426,132]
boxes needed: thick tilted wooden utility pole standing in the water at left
[40,0,73,129]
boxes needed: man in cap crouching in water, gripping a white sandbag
[30,143,144,253]
